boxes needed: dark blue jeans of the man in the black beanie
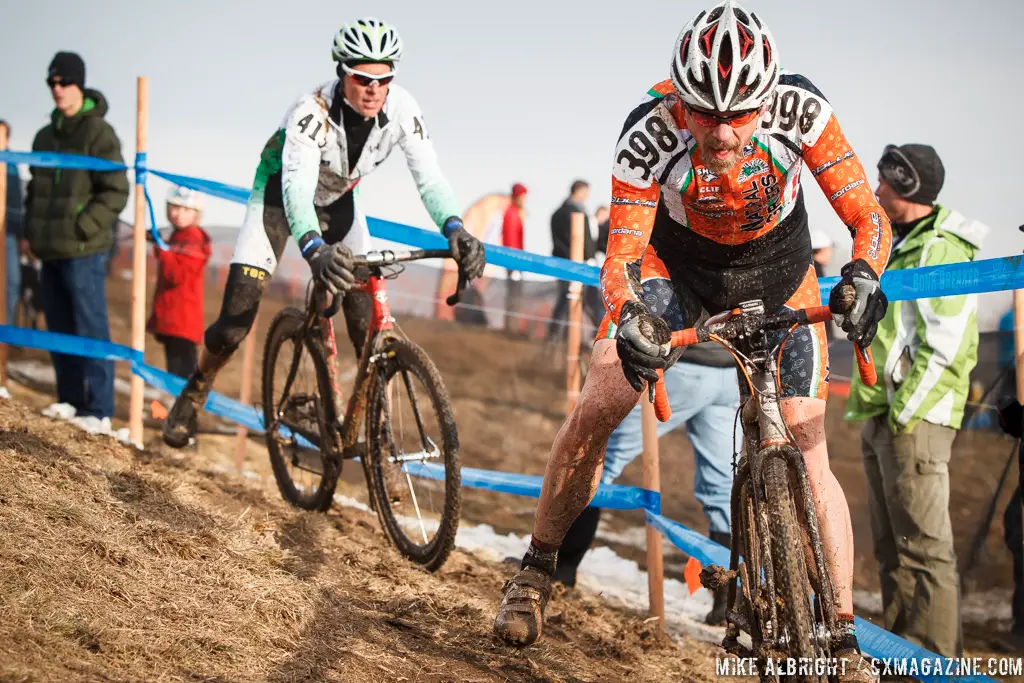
[40,254,114,418]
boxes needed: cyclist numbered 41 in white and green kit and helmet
[164,17,485,447]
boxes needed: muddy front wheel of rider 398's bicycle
[763,450,817,682]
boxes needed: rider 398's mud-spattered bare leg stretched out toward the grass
[534,339,639,546]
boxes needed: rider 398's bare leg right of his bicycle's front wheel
[780,396,853,613]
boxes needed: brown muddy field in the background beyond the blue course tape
[4,270,1016,680]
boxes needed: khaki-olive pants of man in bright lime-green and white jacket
[861,415,963,657]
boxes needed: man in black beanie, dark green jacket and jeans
[25,52,128,431]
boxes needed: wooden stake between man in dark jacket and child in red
[128,76,150,443]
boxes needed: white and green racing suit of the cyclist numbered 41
[231,79,460,272]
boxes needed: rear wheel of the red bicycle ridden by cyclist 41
[263,307,341,512]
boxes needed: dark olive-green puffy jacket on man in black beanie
[25,89,128,261]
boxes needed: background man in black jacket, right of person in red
[548,180,604,342]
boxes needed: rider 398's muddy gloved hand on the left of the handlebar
[615,301,672,391]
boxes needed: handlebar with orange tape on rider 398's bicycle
[654,306,878,422]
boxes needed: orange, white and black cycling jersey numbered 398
[601,71,892,322]
